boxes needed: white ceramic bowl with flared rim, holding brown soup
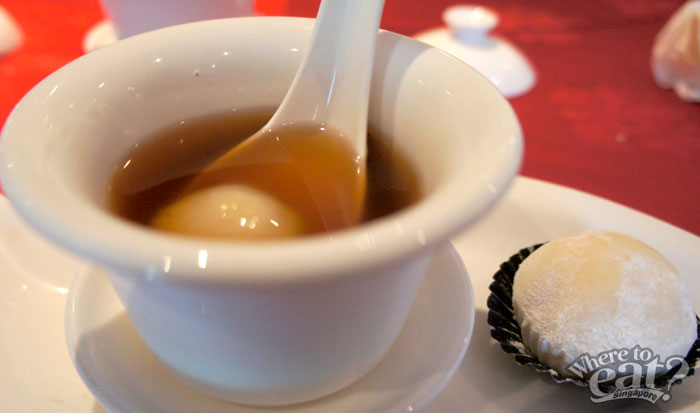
[0,18,522,404]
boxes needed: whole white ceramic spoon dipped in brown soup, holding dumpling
[152,0,384,239]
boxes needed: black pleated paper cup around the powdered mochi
[487,243,700,391]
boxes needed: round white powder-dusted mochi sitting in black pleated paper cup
[513,231,697,376]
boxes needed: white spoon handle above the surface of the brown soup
[269,0,384,157]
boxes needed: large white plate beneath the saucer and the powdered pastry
[0,177,700,413]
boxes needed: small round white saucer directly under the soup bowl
[65,244,474,413]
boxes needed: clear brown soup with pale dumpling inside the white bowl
[108,109,421,240]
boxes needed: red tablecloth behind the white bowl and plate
[0,0,700,234]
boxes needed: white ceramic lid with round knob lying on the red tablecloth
[415,5,535,97]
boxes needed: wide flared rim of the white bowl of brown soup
[0,17,523,286]
